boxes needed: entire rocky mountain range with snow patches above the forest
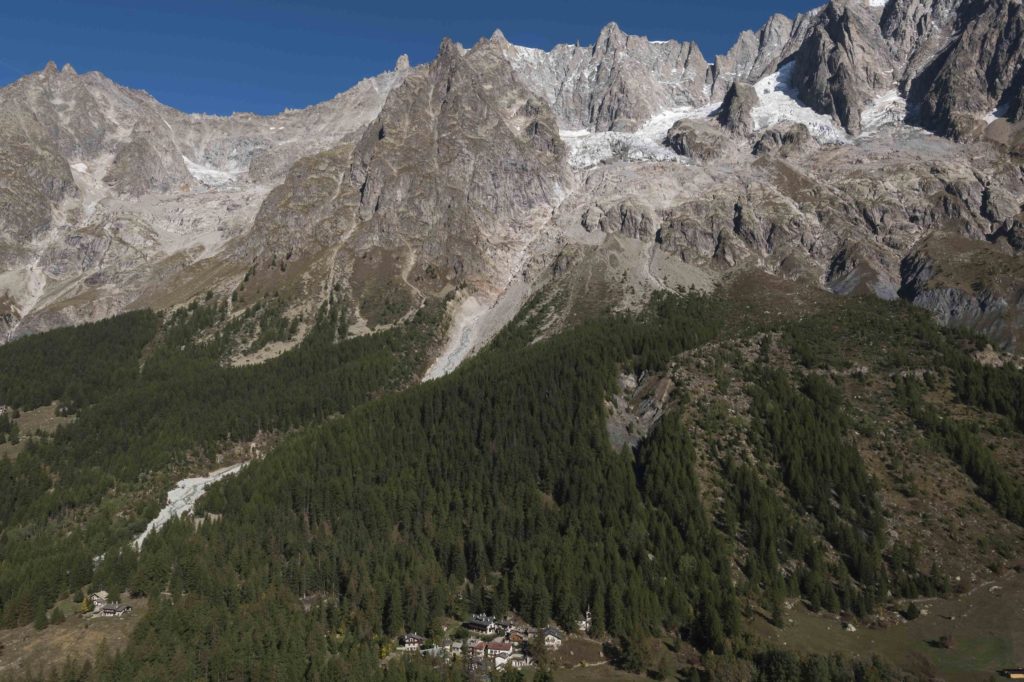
[0,0,1024,360]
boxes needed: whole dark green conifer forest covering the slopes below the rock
[0,284,1021,680]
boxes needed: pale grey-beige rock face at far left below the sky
[0,57,411,342]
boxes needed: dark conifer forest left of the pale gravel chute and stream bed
[0,302,441,626]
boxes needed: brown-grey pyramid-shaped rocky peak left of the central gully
[248,35,570,316]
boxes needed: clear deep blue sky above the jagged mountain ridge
[0,0,823,114]
